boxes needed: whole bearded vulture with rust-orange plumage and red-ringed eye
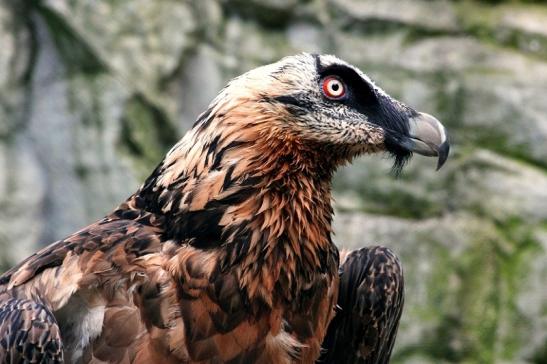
[0,54,449,364]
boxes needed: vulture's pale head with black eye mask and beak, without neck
[188,54,449,176]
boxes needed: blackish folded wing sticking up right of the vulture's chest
[318,247,404,364]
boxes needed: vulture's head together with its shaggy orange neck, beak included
[135,54,449,276]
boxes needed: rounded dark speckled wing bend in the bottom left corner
[0,298,63,364]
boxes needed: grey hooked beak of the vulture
[401,113,450,170]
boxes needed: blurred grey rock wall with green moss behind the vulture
[0,0,547,364]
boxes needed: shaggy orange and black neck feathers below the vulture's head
[131,96,337,301]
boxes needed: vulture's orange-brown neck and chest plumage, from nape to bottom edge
[127,96,338,362]
